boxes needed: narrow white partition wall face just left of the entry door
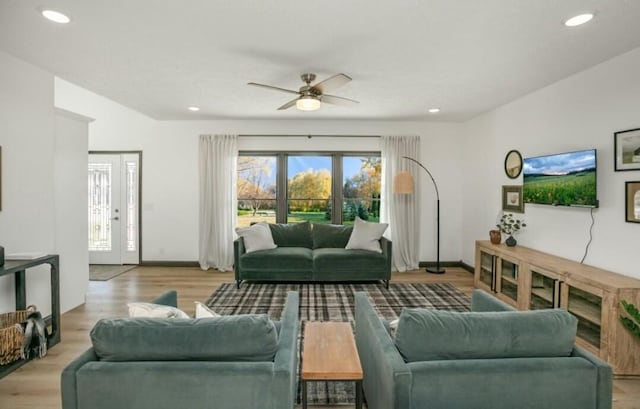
[54,109,91,311]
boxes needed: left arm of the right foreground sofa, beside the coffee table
[355,292,412,409]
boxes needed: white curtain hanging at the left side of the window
[199,135,238,271]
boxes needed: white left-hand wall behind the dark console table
[0,52,88,315]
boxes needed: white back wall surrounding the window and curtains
[55,78,463,261]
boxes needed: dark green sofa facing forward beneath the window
[233,222,391,288]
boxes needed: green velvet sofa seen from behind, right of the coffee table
[355,290,612,409]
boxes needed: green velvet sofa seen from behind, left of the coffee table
[61,291,299,409]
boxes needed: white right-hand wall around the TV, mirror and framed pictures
[462,48,640,278]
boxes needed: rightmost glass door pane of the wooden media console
[562,281,604,353]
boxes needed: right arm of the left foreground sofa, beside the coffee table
[273,291,300,409]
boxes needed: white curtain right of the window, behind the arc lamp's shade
[380,136,420,271]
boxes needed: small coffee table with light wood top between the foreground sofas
[300,322,362,409]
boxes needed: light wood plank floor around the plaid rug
[0,267,640,409]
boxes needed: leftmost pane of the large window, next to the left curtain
[237,155,277,227]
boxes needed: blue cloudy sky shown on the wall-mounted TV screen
[524,149,596,175]
